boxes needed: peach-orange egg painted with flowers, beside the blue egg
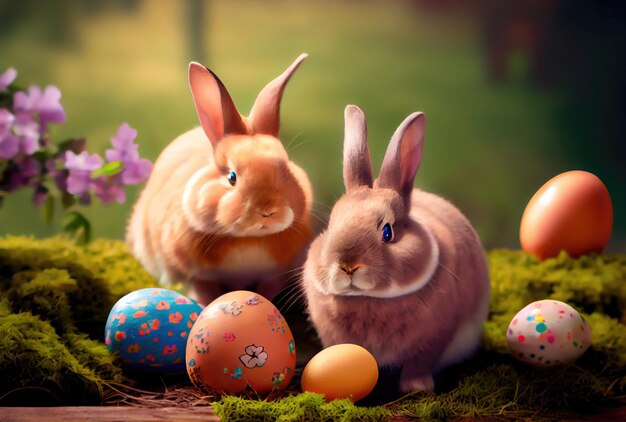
[186,290,296,394]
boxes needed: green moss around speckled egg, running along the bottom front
[214,250,626,420]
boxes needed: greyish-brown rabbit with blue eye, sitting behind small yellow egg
[303,106,489,392]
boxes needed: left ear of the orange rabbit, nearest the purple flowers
[189,62,246,145]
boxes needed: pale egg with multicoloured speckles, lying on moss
[506,299,591,367]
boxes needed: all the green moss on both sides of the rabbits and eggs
[0,237,626,421]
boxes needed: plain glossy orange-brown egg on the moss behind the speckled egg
[520,170,613,260]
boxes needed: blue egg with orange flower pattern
[104,288,202,373]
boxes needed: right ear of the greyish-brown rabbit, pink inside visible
[376,113,426,203]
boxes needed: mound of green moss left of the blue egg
[0,237,155,404]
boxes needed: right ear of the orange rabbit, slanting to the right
[248,54,308,137]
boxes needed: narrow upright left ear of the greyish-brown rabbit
[343,105,373,191]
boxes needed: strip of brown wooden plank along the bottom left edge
[0,406,220,422]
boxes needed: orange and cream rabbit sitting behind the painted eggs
[127,54,312,305]
